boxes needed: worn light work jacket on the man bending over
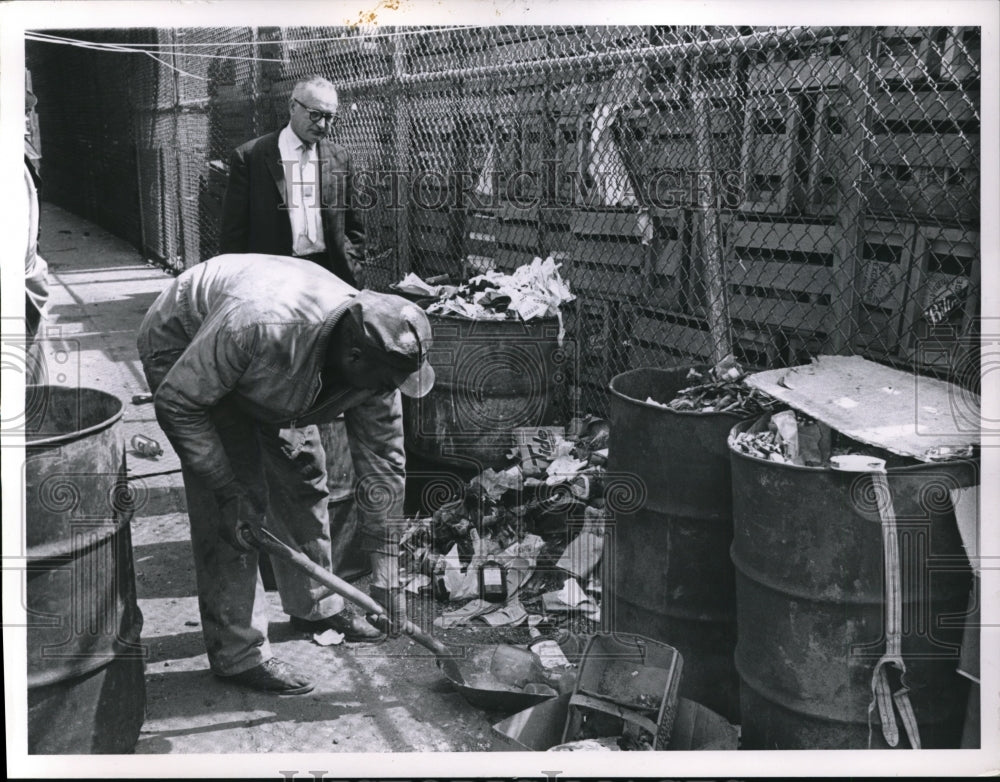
[138,254,405,548]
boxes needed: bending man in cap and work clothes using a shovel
[138,254,434,694]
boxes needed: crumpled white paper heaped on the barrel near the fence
[392,256,576,334]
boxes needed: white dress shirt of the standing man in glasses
[278,125,326,255]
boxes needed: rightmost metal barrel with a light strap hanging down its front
[731,421,978,749]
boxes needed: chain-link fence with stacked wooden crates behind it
[28,26,981,413]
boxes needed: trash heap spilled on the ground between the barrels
[400,417,609,629]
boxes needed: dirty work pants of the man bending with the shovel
[144,356,344,676]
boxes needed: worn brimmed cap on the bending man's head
[348,291,434,398]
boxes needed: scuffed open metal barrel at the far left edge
[25,386,146,754]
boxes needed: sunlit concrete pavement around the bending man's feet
[40,204,505,760]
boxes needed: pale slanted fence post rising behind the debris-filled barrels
[691,62,733,364]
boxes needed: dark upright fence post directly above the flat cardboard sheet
[827,27,877,354]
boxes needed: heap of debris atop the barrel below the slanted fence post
[646,355,777,415]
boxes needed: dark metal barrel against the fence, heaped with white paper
[405,314,568,472]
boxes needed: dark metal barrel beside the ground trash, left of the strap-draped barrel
[608,367,740,723]
